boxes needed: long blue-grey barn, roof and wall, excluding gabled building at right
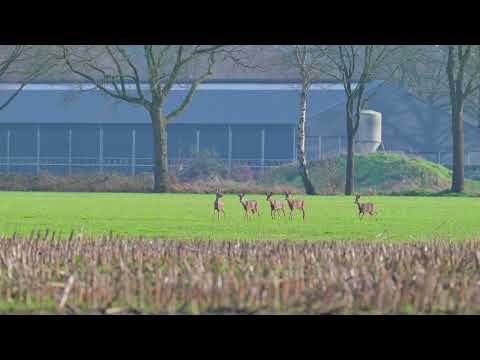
[0,81,343,174]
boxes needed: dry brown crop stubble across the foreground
[0,233,480,314]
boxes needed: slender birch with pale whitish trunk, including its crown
[279,45,323,195]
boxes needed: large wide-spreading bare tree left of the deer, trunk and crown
[61,45,246,192]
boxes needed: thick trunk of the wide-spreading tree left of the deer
[150,108,169,193]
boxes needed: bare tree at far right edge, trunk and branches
[380,45,480,192]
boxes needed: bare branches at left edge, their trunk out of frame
[0,45,56,111]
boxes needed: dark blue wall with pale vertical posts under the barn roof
[0,124,294,174]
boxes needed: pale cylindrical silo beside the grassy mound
[356,110,382,154]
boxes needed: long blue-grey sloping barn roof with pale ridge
[0,83,360,125]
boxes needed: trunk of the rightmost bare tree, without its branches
[452,99,465,193]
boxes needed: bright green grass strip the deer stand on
[0,192,480,241]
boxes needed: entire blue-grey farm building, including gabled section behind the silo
[0,80,480,174]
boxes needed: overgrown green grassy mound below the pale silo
[262,153,480,194]
